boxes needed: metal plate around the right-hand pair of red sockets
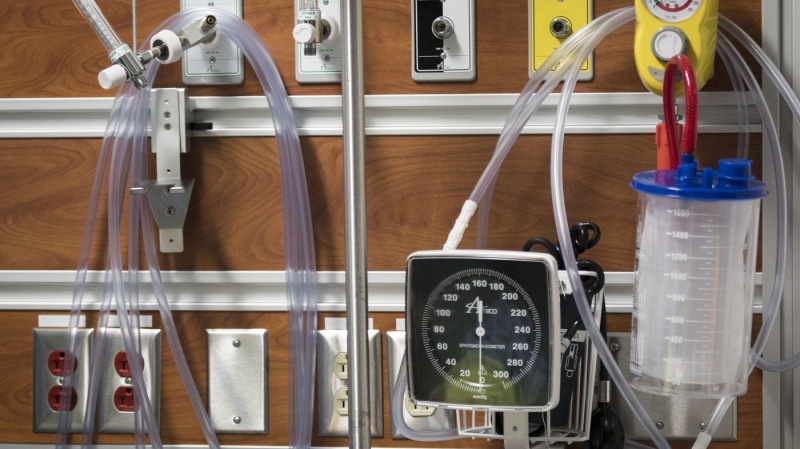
[97,328,161,434]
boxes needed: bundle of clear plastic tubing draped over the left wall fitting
[62,9,316,447]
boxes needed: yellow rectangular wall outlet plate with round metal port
[528,0,594,81]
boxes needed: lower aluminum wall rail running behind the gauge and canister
[0,271,762,313]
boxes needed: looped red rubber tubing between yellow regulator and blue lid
[663,55,697,169]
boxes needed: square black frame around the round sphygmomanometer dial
[406,250,560,411]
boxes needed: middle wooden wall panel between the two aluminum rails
[0,135,760,271]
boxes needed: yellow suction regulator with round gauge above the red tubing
[634,0,719,95]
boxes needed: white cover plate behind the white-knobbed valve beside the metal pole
[294,0,342,84]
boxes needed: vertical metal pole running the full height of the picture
[342,0,372,449]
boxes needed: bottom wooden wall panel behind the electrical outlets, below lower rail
[0,312,762,449]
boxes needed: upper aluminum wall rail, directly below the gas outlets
[0,92,761,138]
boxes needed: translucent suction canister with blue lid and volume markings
[630,154,767,398]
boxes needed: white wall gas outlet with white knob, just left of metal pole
[292,0,342,84]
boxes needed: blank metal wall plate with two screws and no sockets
[206,329,269,434]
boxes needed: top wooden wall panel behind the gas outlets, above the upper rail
[0,0,761,98]
